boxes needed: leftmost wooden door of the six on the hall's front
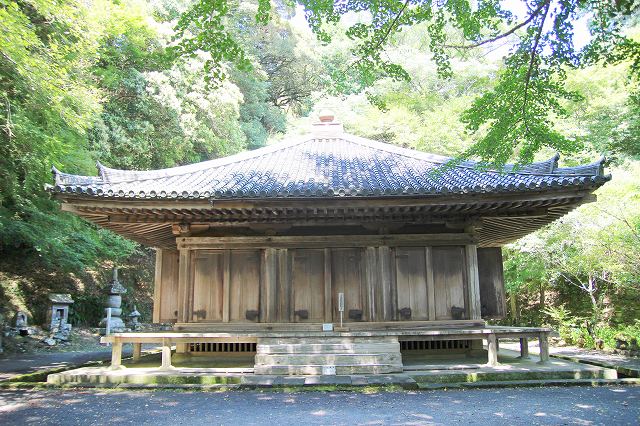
[192,251,224,321]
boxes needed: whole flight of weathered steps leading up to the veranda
[254,336,402,375]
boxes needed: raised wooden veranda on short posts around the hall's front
[100,326,553,369]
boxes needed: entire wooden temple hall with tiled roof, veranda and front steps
[49,116,610,374]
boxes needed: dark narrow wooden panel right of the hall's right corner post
[478,247,506,319]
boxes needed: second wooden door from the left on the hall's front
[229,250,260,322]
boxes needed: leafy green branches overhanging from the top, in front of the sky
[175,0,640,166]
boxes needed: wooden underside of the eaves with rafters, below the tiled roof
[58,191,593,249]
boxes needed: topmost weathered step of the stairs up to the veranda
[256,342,400,354]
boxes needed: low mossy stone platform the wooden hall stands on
[48,350,618,389]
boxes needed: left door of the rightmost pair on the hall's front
[395,247,429,321]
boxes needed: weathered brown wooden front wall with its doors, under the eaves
[164,238,502,323]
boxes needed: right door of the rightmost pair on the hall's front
[431,247,468,320]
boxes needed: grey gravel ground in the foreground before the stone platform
[0,386,640,426]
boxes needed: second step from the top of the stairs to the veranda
[255,353,402,366]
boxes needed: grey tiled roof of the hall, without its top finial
[49,133,610,199]
